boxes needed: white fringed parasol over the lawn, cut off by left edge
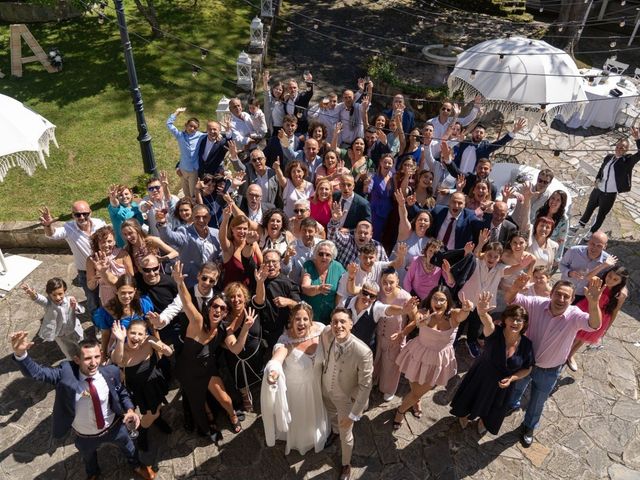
[0,94,58,182]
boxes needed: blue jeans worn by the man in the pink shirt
[510,365,562,429]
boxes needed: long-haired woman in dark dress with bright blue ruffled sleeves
[93,274,153,362]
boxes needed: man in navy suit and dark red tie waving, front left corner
[11,331,156,480]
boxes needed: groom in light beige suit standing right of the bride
[320,308,373,480]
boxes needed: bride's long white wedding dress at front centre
[262,322,331,455]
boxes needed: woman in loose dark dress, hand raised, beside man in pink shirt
[451,292,534,435]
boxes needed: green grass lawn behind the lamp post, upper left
[0,0,255,221]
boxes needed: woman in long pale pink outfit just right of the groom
[373,268,411,402]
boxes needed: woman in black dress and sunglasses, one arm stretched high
[171,262,255,442]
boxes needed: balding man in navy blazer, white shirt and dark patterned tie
[430,192,483,250]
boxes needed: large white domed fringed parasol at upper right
[448,37,587,118]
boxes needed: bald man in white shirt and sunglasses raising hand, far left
[40,200,106,315]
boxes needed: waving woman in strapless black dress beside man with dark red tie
[111,319,173,450]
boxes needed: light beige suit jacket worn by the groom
[320,326,373,417]
